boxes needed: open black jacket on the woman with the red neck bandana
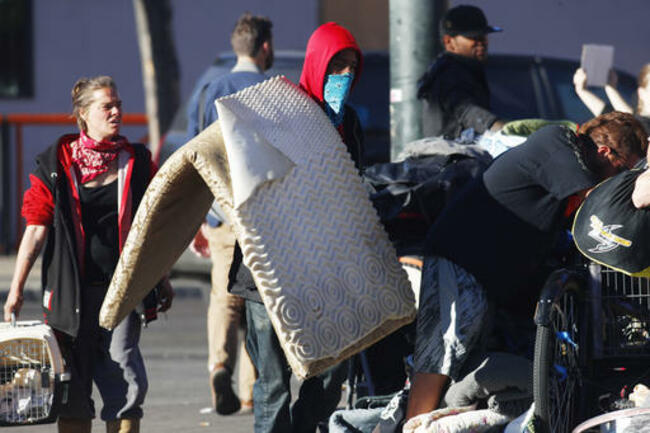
[34,137,156,337]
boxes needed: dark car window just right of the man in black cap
[485,56,542,119]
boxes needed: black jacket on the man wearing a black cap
[417,52,497,139]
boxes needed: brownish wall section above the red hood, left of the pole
[320,0,388,50]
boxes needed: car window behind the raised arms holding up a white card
[543,60,636,124]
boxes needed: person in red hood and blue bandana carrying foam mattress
[242,23,363,433]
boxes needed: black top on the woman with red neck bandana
[79,181,119,285]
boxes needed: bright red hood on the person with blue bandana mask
[300,22,363,107]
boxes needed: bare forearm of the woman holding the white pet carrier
[4,225,49,321]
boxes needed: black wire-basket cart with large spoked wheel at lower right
[533,263,650,433]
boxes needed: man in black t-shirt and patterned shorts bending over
[407,112,647,419]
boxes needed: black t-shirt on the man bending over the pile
[426,126,597,305]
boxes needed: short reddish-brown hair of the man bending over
[579,111,648,166]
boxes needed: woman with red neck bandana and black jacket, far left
[4,76,173,433]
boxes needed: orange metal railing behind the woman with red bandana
[0,113,147,250]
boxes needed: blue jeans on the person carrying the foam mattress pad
[246,300,348,433]
